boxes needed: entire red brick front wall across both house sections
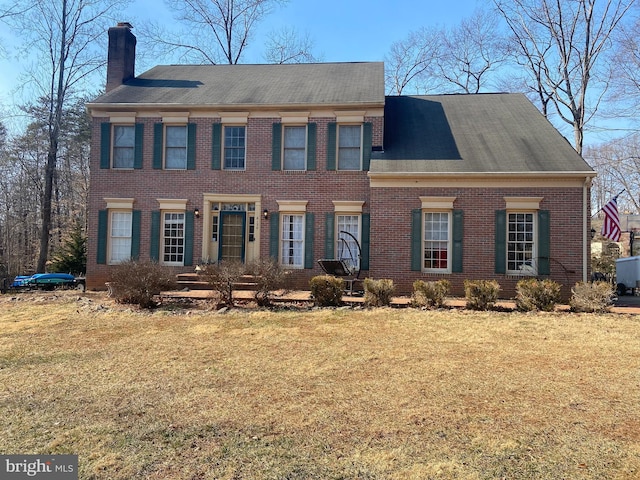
[87,113,590,298]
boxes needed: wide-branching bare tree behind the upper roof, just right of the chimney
[145,0,288,65]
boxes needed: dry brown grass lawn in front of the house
[0,294,640,480]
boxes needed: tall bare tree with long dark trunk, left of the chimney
[2,0,126,272]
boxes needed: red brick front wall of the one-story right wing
[370,186,583,298]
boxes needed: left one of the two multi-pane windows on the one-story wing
[422,211,451,273]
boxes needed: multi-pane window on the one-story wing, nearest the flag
[507,212,537,275]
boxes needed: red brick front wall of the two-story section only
[87,117,382,288]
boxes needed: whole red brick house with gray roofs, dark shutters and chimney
[87,24,595,297]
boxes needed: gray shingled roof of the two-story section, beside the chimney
[91,62,384,107]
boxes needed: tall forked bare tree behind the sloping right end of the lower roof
[493,0,634,153]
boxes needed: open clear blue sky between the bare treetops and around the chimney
[0,0,480,123]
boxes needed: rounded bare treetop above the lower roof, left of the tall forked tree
[436,9,508,93]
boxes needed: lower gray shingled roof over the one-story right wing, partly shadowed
[370,94,593,174]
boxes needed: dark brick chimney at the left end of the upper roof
[106,22,136,92]
